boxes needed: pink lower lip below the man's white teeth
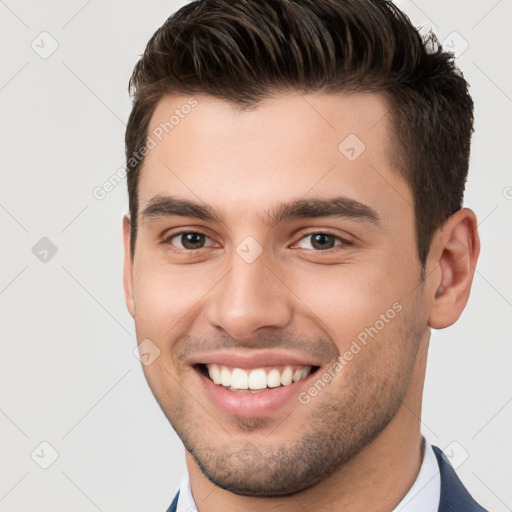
[196,370,312,418]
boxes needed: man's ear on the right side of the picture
[427,208,480,329]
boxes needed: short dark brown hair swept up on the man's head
[126,0,473,267]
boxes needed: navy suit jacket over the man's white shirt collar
[167,446,487,512]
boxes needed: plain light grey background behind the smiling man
[0,0,512,512]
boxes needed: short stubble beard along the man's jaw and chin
[148,306,424,497]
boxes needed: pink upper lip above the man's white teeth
[190,349,320,369]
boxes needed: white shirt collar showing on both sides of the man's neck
[176,439,441,512]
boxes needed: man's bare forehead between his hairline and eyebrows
[139,93,412,224]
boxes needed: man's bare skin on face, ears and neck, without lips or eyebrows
[123,93,479,512]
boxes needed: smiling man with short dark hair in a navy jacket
[123,0,484,512]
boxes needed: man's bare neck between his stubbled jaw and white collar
[186,340,427,512]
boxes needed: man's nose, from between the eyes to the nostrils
[207,248,293,340]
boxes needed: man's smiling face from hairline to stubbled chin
[125,94,428,496]
